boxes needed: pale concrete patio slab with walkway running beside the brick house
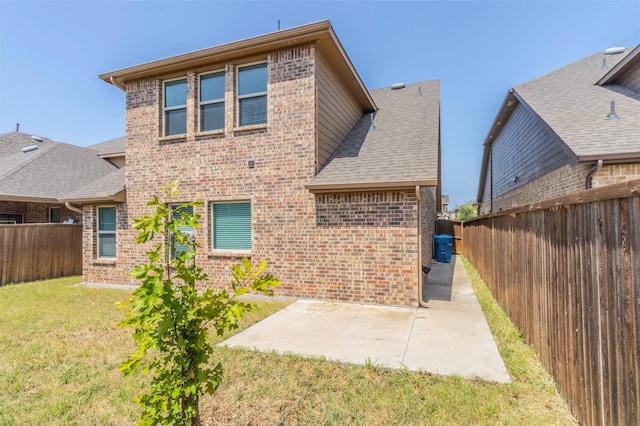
[221,256,510,382]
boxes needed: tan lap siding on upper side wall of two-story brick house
[317,55,362,170]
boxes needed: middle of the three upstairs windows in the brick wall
[200,71,224,132]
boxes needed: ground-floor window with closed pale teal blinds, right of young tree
[213,203,251,250]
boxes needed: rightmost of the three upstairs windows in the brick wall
[238,63,267,126]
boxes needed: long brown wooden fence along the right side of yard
[464,180,640,425]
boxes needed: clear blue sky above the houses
[0,0,640,207]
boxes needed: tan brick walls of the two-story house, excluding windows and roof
[83,46,428,306]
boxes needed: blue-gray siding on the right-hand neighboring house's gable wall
[483,105,569,203]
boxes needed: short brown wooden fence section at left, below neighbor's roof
[0,223,82,285]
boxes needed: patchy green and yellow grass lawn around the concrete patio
[0,263,576,425]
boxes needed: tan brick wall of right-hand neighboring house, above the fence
[480,163,640,214]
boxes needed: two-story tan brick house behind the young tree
[74,21,440,305]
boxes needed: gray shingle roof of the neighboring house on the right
[514,49,640,159]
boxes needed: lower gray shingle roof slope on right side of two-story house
[307,80,440,192]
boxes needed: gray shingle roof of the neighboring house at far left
[0,132,116,202]
